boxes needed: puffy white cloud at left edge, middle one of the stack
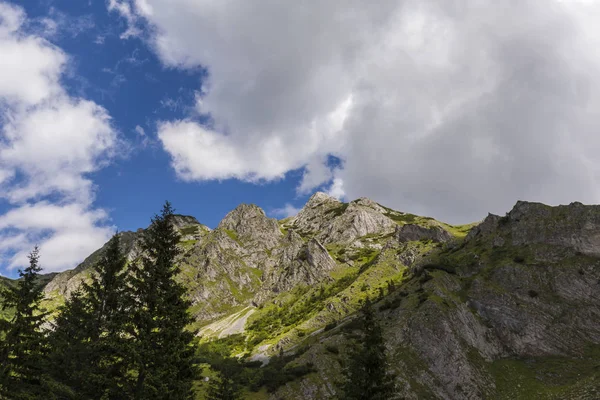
[0,97,116,203]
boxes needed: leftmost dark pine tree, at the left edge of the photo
[0,247,47,399]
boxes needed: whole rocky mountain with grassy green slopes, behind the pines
[0,193,600,399]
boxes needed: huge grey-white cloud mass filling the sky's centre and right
[111,0,600,222]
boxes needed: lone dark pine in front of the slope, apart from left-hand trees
[340,302,395,400]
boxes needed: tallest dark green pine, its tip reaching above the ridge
[128,202,196,400]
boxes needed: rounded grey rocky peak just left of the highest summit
[217,204,283,248]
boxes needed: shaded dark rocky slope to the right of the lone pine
[272,202,600,400]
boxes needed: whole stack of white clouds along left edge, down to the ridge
[0,2,117,271]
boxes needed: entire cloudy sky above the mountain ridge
[0,0,600,276]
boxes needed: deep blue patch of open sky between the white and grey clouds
[20,0,306,225]
